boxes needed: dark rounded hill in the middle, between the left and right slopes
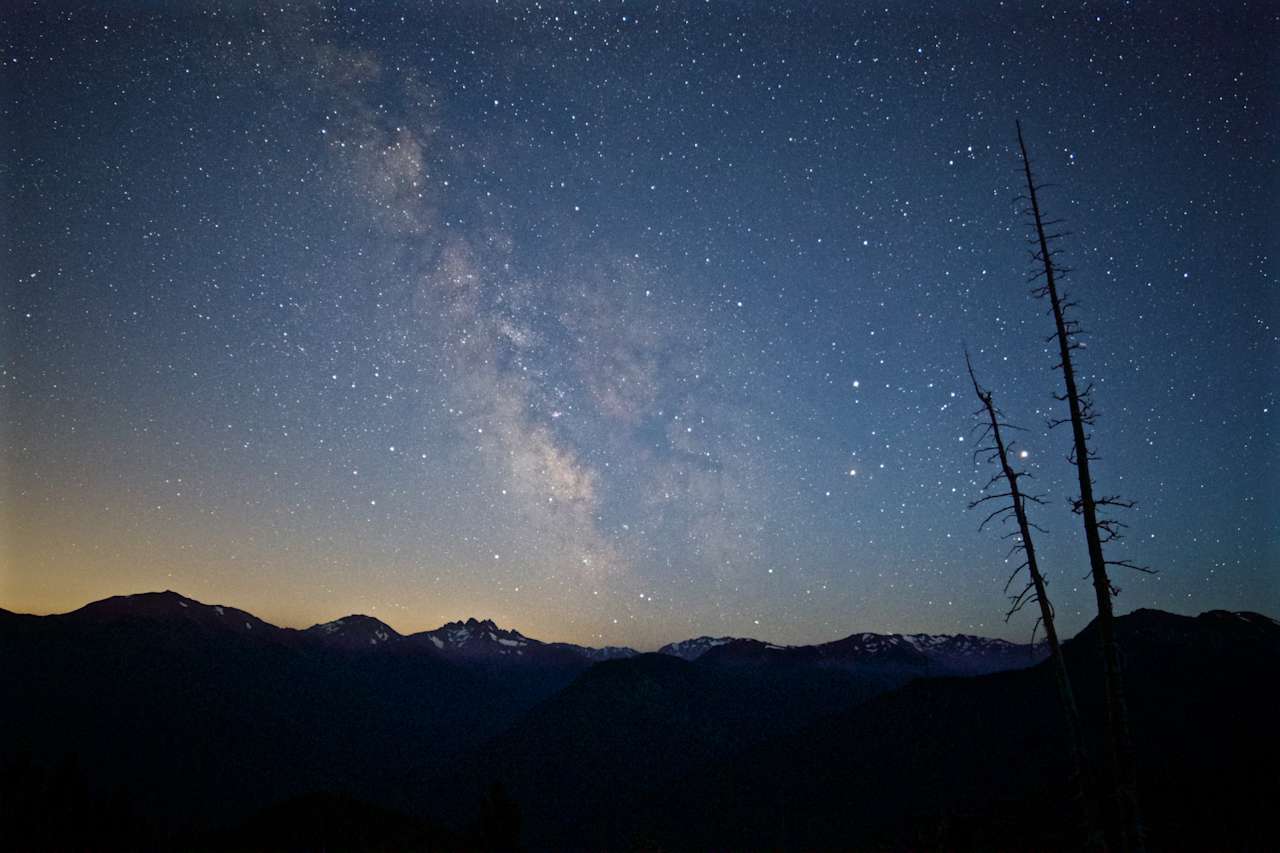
[422,654,883,847]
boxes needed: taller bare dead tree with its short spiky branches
[1018,122,1151,850]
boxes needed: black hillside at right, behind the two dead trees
[617,611,1280,849]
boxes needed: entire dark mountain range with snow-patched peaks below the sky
[0,592,1280,849]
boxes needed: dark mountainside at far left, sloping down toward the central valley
[0,593,590,831]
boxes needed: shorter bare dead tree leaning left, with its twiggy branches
[964,350,1106,850]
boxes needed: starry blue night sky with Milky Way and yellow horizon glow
[0,0,1280,648]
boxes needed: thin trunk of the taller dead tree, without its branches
[1018,123,1146,850]
